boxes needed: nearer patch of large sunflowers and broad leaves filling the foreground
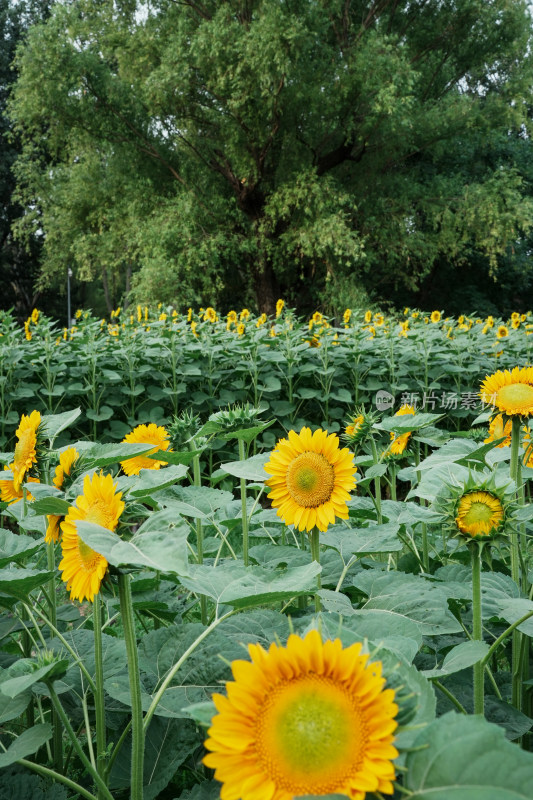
[0,362,533,800]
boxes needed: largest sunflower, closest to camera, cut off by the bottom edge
[204,630,398,800]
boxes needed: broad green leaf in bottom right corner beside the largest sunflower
[405,712,533,800]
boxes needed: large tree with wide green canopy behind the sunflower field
[11,0,533,311]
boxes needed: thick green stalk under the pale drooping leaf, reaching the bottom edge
[118,573,144,800]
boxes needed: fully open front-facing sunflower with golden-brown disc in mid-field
[265,428,356,531]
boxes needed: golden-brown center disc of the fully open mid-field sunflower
[287,452,335,508]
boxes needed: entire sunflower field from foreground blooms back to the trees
[0,300,533,800]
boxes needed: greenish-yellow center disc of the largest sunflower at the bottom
[257,674,366,795]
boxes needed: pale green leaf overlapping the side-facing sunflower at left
[76,520,190,575]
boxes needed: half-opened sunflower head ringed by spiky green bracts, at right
[435,466,517,540]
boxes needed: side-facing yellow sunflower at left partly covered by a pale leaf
[59,473,124,602]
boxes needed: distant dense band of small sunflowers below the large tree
[0,301,533,454]
